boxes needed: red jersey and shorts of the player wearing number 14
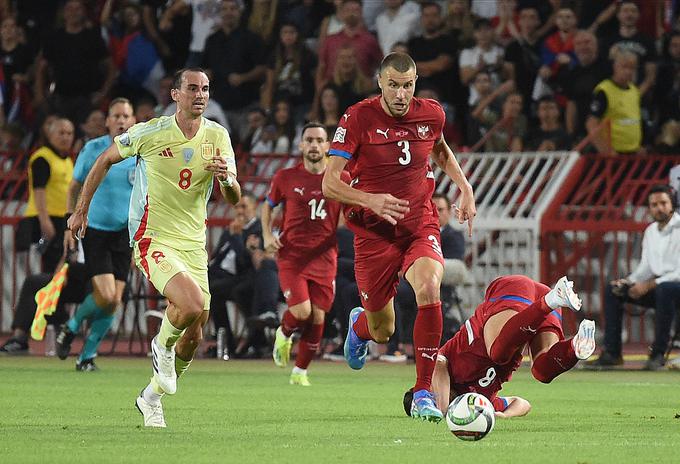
[267,163,349,310]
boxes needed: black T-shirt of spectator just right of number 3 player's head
[408,34,460,103]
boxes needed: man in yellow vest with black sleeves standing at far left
[17,118,74,272]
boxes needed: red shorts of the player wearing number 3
[354,223,444,312]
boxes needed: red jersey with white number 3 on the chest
[329,96,445,238]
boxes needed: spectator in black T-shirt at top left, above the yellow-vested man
[34,0,116,120]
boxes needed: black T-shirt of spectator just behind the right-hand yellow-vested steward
[558,60,609,136]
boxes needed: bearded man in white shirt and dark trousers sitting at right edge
[586,185,680,370]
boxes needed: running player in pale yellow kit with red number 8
[68,68,241,427]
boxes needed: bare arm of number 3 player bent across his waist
[322,156,409,225]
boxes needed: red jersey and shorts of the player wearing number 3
[329,96,445,311]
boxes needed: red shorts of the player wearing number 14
[279,267,335,312]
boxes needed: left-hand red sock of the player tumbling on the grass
[490,297,552,364]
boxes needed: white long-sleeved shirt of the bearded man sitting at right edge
[628,213,680,284]
